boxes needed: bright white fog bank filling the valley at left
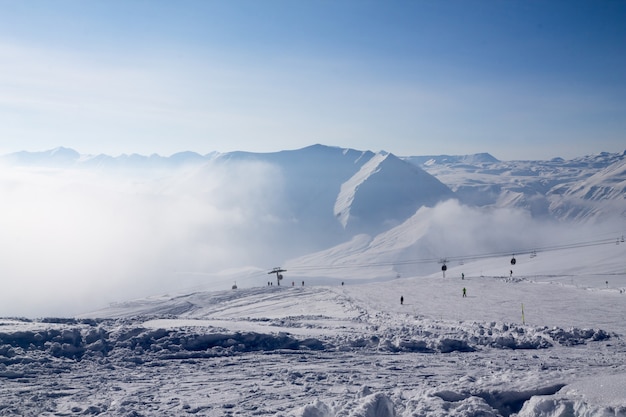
[0,162,288,316]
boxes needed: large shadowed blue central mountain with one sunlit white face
[214,145,454,236]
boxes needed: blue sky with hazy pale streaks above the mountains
[0,0,626,160]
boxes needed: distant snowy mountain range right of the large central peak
[403,152,626,221]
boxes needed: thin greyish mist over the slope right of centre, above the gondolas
[402,200,620,273]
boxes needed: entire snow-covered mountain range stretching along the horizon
[6,145,626,229]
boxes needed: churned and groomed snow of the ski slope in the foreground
[0,239,626,417]
